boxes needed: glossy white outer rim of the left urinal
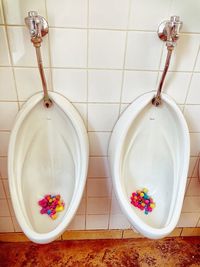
[8,92,89,244]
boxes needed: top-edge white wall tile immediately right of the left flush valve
[46,0,87,28]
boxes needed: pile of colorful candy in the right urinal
[131,188,156,214]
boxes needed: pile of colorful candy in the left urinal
[38,195,65,220]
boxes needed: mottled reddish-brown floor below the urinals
[0,237,200,267]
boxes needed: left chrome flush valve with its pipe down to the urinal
[25,11,52,108]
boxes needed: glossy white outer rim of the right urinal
[108,91,190,239]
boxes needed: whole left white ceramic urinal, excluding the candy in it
[8,92,88,243]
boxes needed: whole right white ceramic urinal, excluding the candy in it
[108,92,190,239]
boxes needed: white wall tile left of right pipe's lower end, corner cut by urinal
[122,71,158,103]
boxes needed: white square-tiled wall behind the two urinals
[0,0,200,232]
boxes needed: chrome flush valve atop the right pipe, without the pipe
[158,16,183,49]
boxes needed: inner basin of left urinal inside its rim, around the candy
[15,101,77,233]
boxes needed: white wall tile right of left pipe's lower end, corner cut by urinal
[53,69,87,102]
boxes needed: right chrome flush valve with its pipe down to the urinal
[152,16,183,107]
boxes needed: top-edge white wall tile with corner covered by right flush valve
[129,0,171,31]
